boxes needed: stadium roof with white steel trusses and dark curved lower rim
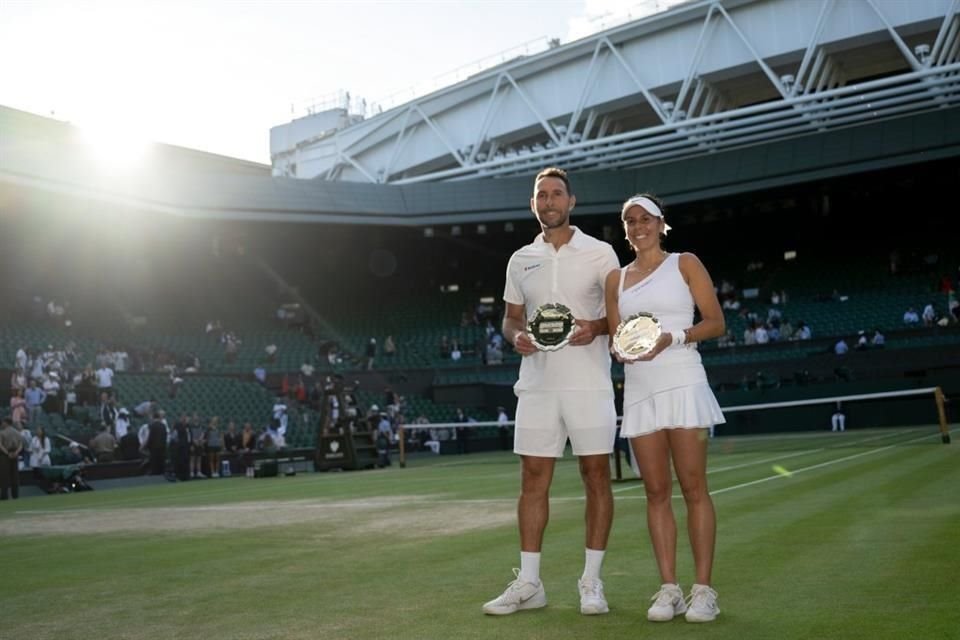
[0,0,960,226]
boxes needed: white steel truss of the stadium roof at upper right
[274,0,960,184]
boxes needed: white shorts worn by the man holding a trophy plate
[513,390,617,458]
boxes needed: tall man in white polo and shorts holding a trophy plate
[483,168,617,615]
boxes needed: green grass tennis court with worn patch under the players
[0,425,960,640]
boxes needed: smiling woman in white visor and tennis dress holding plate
[605,195,726,622]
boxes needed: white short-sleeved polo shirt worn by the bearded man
[503,227,620,392]
